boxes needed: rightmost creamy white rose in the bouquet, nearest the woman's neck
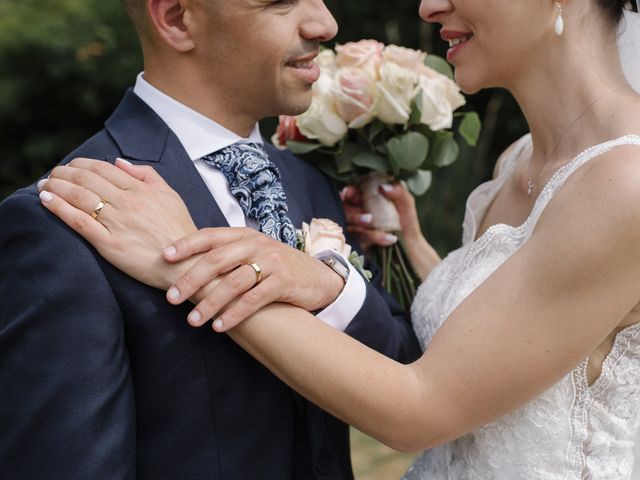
[419,76,465,131]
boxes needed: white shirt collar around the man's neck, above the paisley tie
[133,72,263,160]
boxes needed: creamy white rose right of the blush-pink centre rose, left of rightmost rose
[374,62,418,124]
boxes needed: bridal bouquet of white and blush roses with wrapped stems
[273,40,480,307]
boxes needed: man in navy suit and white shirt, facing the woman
[0,0,418,480]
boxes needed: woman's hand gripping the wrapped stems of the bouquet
[341,182,440,280]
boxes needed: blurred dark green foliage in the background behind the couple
[0,0,526,253]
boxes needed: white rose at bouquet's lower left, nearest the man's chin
[296,95,348,147]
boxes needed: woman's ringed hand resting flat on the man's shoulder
[38,158,197,289]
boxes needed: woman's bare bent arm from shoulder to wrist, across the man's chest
[222,150,640,451]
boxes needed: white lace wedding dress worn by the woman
[405,136,640,480]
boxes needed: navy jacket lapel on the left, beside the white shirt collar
[105,89,229,228]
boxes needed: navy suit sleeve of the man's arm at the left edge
[0,190,135,480]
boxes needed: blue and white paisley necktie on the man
[202,143,296,248]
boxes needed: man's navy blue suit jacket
[0,91,419,480]
